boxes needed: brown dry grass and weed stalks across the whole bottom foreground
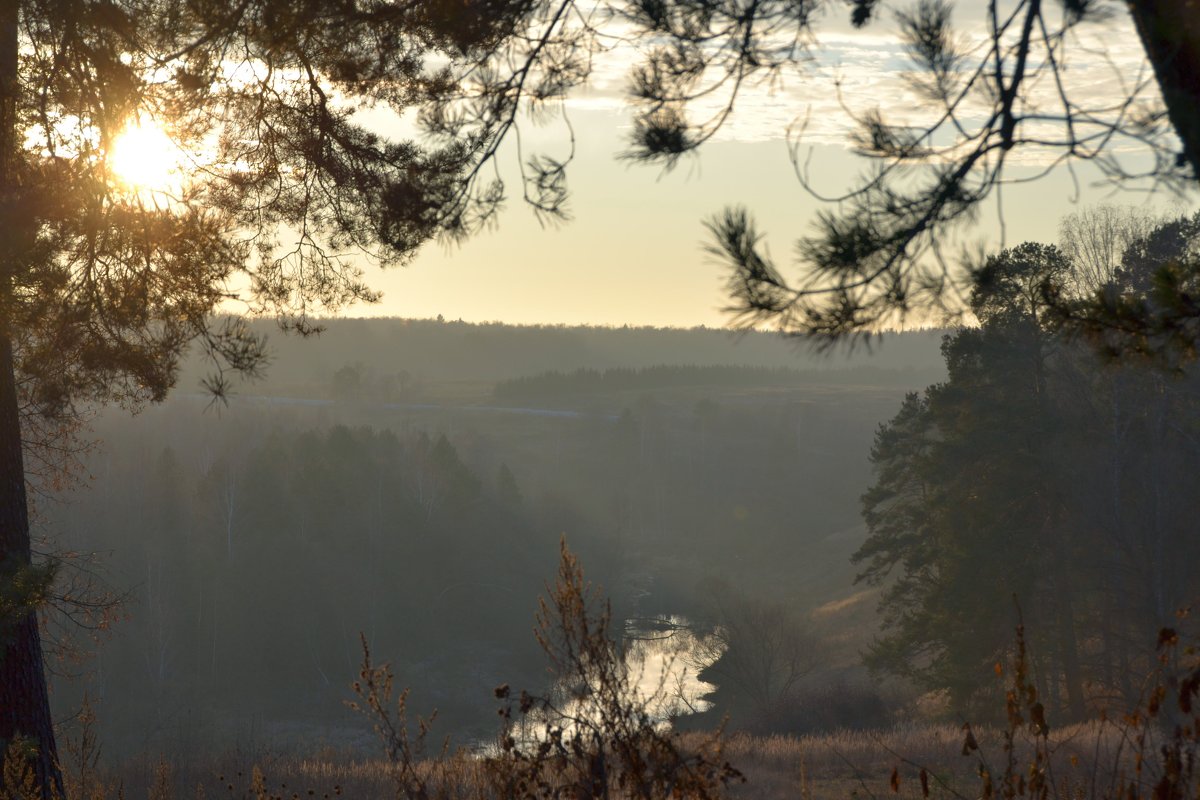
[11,568,1200,800]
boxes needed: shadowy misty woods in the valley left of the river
[48,419,597,753]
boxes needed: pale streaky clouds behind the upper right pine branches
[568,7,1160,166]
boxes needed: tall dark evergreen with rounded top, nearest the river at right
[854,243,1082,716]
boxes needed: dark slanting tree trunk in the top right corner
[1129,0,1200,180]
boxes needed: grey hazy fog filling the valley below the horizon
[37,320,944,757]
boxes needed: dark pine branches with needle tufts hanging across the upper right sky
[629,0,1200,339]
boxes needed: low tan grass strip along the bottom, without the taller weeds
[51,723,1122,800]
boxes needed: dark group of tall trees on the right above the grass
[854,214,1200,718]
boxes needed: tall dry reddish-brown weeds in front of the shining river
[354,543,742,800]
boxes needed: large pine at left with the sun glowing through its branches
[0,0,590,796]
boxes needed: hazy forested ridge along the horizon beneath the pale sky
[179,319,944,395]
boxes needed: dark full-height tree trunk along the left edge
[0,0,64,800]
